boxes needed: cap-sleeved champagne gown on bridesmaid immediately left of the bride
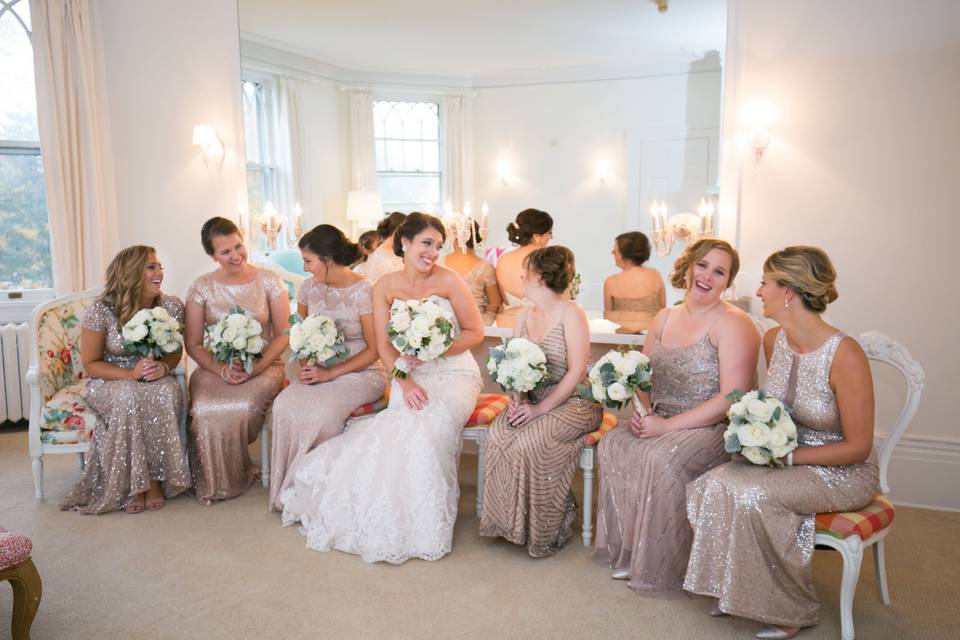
[270,278,386,511]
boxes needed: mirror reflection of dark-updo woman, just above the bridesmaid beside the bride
[497,209,553,327]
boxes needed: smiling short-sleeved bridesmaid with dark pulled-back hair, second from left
[186,218,290,505]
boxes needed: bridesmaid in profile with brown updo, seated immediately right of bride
[480,246,602,558]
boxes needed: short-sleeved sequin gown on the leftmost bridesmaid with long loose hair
[60,295,190,514]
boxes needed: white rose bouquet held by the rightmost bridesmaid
[723,390,797,467]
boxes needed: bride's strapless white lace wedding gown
[280,296,480,564]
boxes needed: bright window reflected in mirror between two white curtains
[373,100,440,212]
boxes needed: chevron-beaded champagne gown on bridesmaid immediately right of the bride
[480,308,603,558]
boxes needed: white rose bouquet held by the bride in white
[387,299,453,379]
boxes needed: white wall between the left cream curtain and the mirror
[93,0,245,296]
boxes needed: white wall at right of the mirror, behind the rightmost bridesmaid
[721,0,960,508]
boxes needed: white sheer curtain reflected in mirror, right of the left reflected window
[264,78,303,246]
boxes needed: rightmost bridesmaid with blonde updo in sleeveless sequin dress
[684,247,879,638]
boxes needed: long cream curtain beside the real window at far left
[30,0,116,295]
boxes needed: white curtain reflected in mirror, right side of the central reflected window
[440,96,476,211]
